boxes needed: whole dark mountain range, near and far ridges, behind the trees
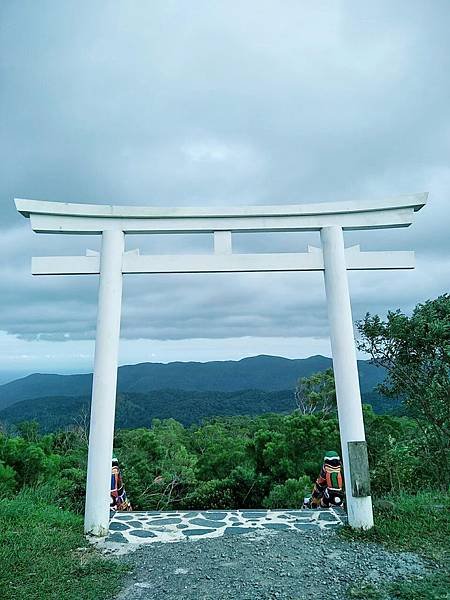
[0,355,392,431]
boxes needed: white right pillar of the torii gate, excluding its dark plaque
[320,226,373,529]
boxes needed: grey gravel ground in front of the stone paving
[119,531,427,600]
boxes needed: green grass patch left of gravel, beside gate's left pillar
[0,488,124,600]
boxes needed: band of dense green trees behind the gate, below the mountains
[0,407,442,512]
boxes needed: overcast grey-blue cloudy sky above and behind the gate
[0,0,450,380]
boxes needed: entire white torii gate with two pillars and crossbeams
[15,193,427,536]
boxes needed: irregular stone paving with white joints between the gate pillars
[105,509,346,546]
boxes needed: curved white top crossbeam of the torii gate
[15,193,427,234]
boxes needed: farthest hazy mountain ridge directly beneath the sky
[0,355,384,410]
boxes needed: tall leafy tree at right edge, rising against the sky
[357,294,450,487]
